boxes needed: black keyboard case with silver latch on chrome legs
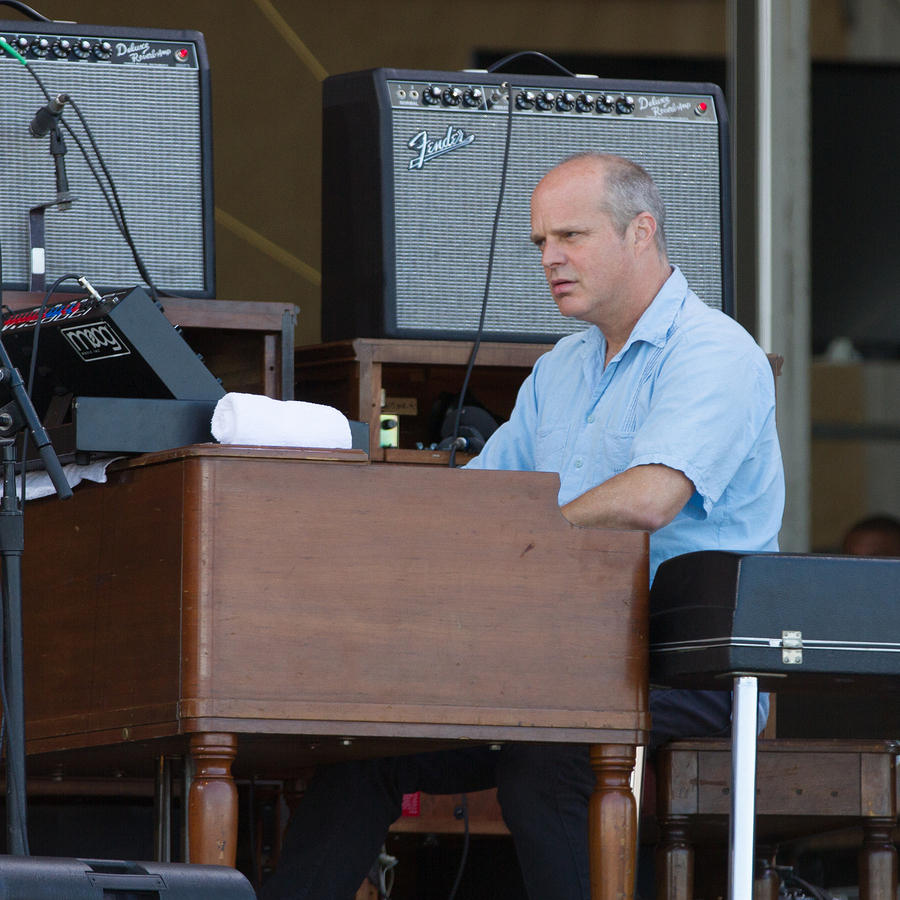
[650,551,900,688]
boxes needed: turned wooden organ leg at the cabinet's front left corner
[188,734,238,867]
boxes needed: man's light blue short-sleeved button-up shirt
[468,268,784,580]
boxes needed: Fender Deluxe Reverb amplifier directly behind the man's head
[322,69,733,341]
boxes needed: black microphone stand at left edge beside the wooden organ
[0,340,72,856]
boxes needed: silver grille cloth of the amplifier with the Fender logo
[393,109,722,335]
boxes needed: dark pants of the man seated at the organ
[260,691,731,900]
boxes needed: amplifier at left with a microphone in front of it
[0,21,215,297]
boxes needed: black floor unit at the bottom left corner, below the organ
[0,856,256,900]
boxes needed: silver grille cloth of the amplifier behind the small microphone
[0,60,207,292]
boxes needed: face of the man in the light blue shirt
[531,161,633,328]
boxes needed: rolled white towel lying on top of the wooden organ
[211,393,352,450]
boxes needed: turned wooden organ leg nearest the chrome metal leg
[590,744,637,900]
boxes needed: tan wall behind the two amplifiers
[8,0,845,343]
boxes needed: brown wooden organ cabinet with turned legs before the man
[23,445,649,900]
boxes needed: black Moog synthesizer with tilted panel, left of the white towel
[0,288,225,428]
